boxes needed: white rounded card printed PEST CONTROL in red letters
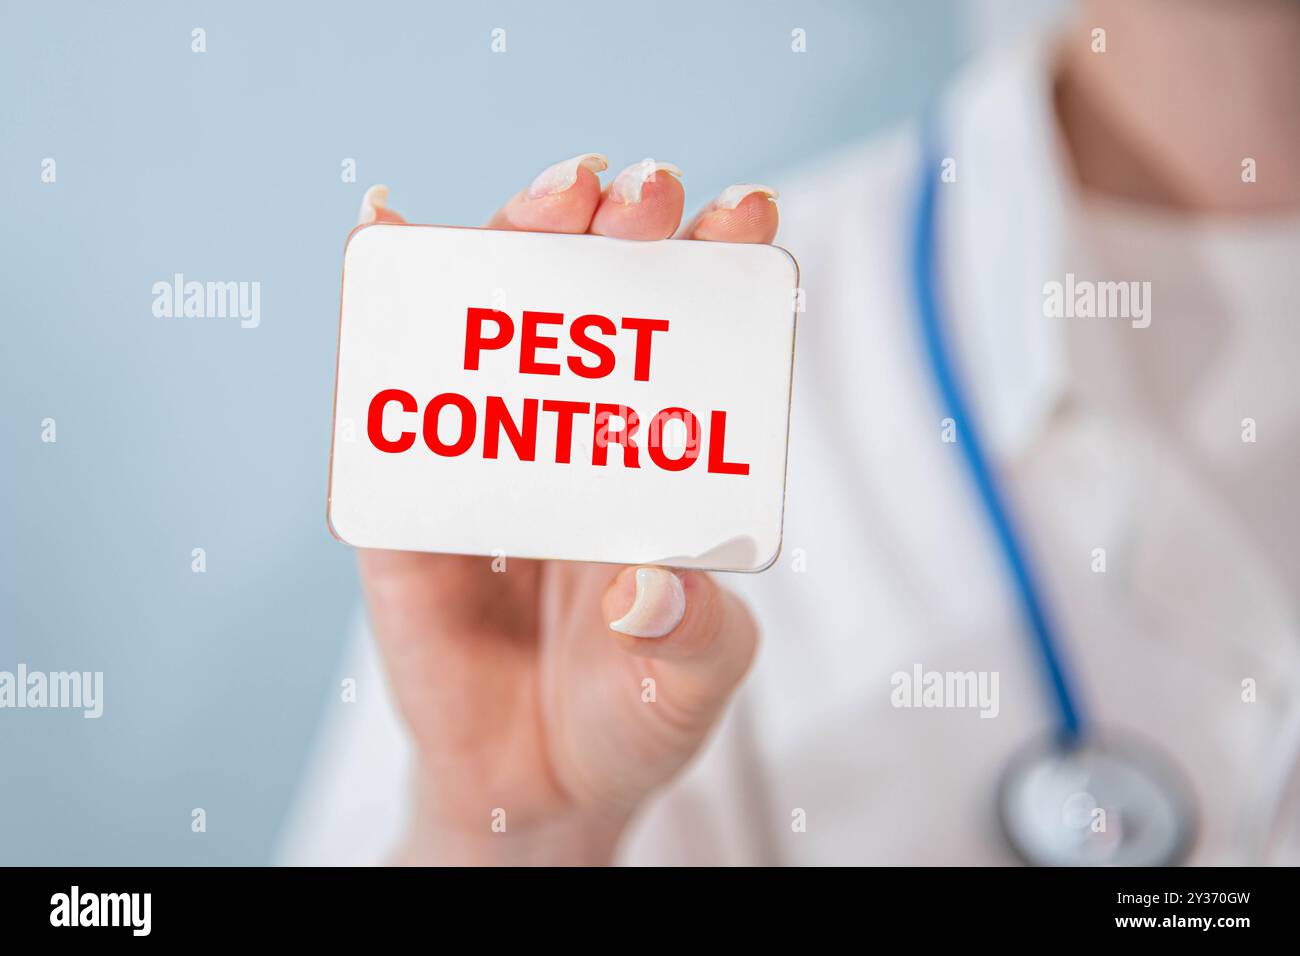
[328,224,798,571]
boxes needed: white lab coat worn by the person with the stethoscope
[282,31,1300,865]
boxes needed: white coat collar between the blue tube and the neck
[937,34,1071,458]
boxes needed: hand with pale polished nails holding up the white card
[360,153,777,864]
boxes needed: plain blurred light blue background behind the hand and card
[0,0,1058,865]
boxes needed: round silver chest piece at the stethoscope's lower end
[998,739,1196,866]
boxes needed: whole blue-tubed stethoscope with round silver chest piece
[911,123,1197,866]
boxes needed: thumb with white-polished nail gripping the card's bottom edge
[603,567,758,702]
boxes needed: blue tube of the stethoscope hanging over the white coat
[911,127,1084,748]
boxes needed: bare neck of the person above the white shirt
[1056,0,1300,213]
